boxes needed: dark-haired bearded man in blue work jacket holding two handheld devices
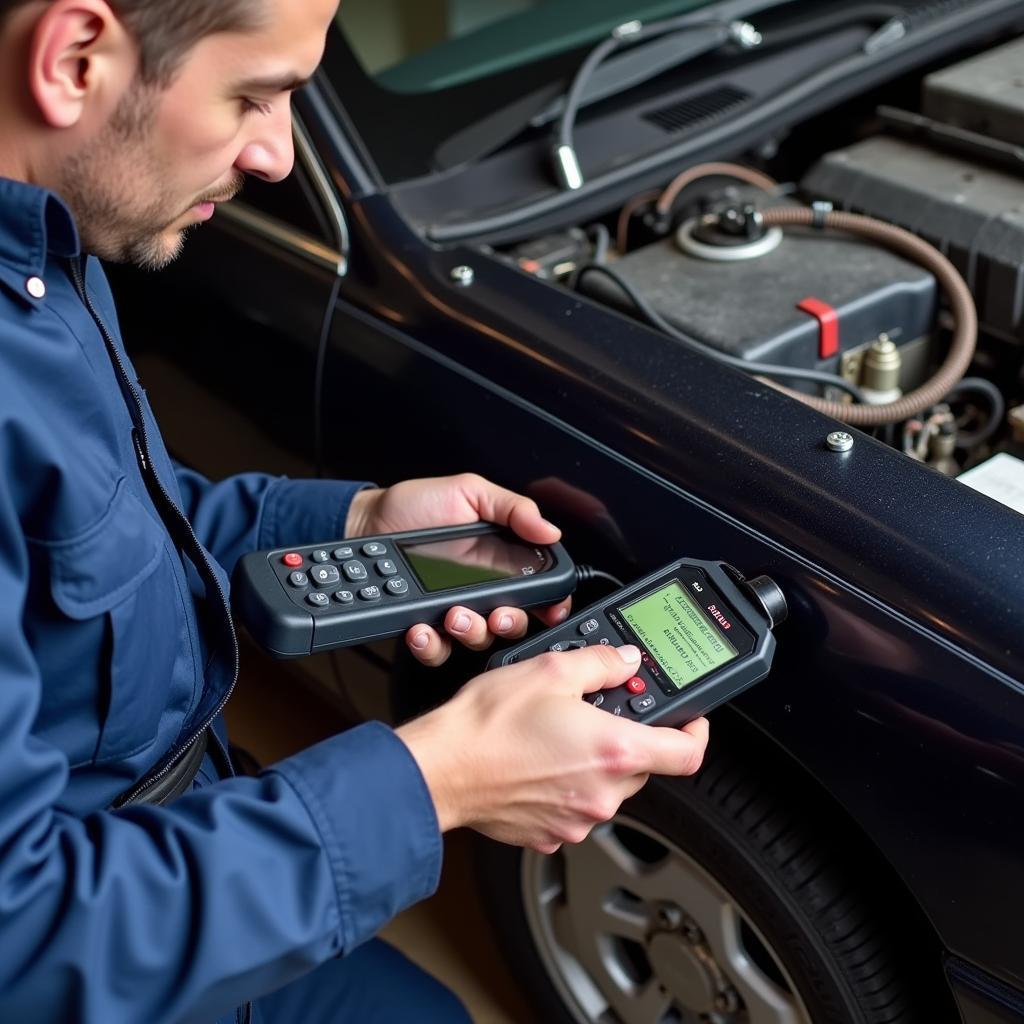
[0,0,708,1024]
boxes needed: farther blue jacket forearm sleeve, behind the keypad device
[174,464,371,574]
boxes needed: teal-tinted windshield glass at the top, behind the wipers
[338,0,710,93]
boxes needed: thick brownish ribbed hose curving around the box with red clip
[763,207,978,427]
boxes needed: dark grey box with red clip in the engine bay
[581,201,937,390]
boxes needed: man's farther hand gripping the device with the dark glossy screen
[345,473,571,666]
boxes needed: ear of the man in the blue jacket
[29,0,138,128]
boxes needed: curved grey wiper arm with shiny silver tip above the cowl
[542,14,762,191]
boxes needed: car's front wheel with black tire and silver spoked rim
[480,730,959,1024]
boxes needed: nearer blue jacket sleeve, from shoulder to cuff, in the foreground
[0,473,441,1024]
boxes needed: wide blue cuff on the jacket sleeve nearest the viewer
[269,722,443,952]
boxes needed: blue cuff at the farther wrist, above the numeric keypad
[257,477,374,548]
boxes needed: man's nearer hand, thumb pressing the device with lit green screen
[397,646,708,853]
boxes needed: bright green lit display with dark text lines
[620,580,739,690]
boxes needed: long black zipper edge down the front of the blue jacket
[71,257,239,806]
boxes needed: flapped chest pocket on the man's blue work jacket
[49,479,196,763]
